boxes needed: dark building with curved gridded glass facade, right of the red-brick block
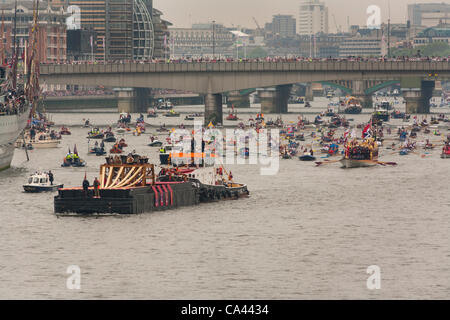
[52,0,161,61]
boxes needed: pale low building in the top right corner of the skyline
[408,3,450,27]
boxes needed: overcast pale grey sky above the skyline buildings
[153,0,442,32]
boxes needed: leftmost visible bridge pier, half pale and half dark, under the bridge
[114,88,150,113]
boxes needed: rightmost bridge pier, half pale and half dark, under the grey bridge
[402,79,434,114]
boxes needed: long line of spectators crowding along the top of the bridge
[43,56,450,65]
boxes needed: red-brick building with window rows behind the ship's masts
[0,1,68,63]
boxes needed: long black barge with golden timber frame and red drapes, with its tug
[54,155,248,214]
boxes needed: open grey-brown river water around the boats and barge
[0,99,450,299]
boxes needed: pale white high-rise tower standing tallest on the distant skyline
[297,0,328,35]
